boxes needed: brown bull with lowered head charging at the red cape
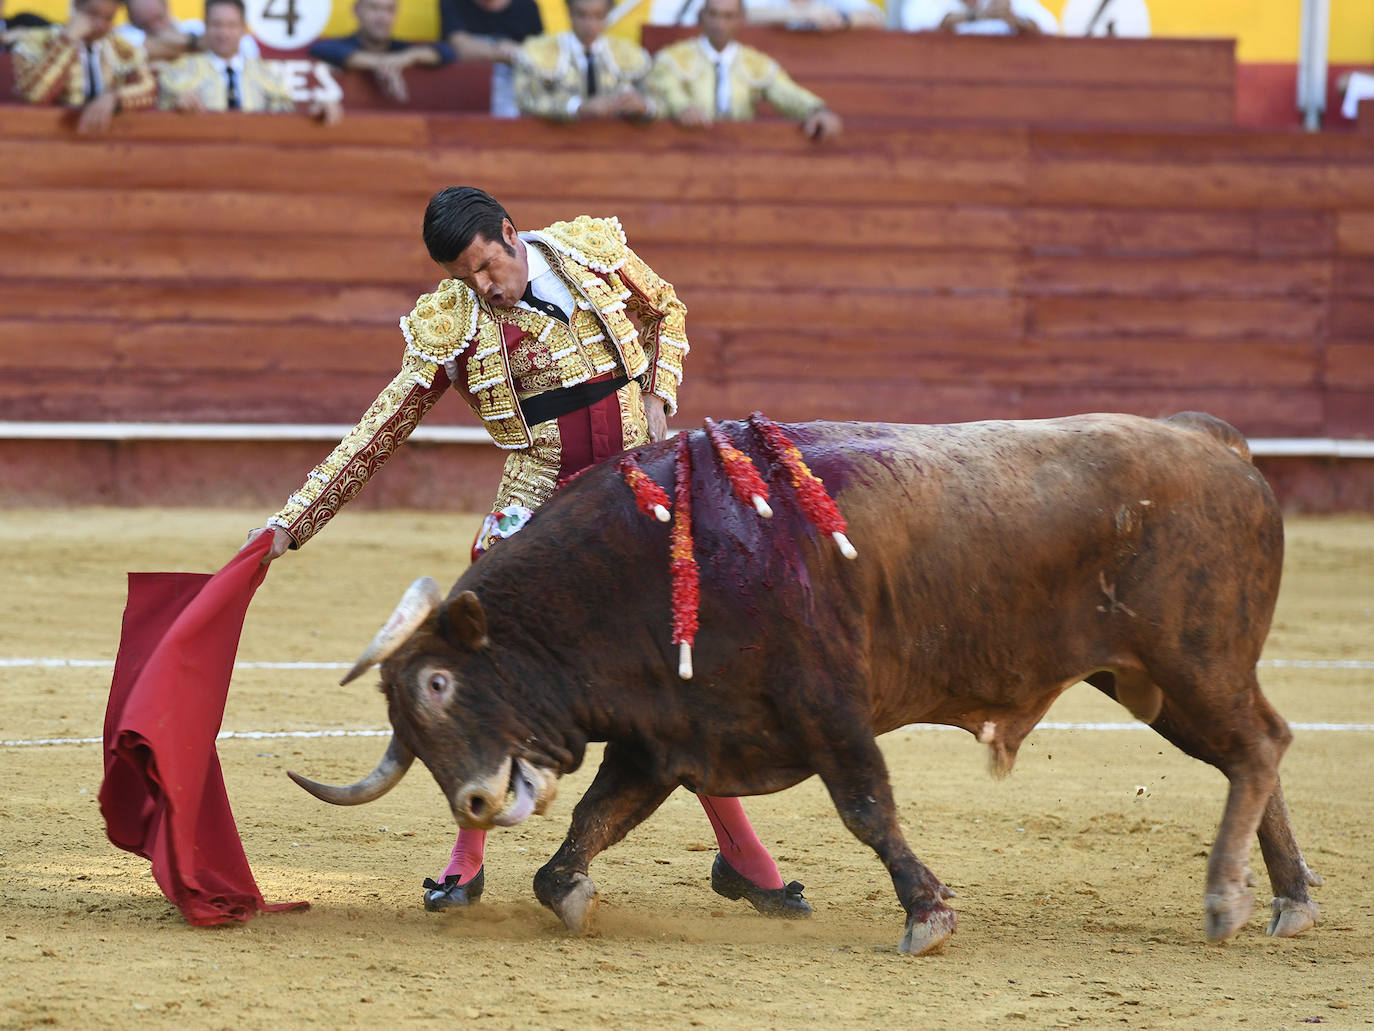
[293,414,1320,953]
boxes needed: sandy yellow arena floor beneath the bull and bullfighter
[0,510,1374,1031]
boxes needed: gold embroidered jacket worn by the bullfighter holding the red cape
[268,214,688,544]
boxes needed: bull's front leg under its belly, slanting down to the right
[819,738,959,955]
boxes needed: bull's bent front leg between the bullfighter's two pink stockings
[534,744,676,933]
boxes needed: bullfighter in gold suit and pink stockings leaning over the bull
[249,187,811,917]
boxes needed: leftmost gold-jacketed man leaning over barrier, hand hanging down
[12,0,157,133]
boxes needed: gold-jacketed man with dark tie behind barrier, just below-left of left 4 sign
[161,0,344,125]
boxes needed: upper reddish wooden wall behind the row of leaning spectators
[0,26,1235,128]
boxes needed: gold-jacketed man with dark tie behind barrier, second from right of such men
[515,0,653,121]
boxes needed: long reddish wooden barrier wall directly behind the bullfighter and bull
[0,107,1374,507]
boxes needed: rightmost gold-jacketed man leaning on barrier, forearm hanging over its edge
[650,0,841,142]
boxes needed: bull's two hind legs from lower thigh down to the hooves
[1150,672,1316,942]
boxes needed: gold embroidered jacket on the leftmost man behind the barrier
[12,25,158,111]
